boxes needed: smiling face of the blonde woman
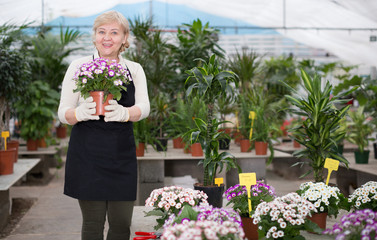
[95,21,128,61]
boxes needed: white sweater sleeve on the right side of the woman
[130,63,150,120]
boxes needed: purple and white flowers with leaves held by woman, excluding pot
[74,58,132,100]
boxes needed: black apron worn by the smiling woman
[64,68,137,201]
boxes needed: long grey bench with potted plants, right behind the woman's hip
[136,144,291,205]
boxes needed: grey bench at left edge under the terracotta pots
[0,159,40,231]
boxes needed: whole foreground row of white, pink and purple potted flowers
[145,181,377,239]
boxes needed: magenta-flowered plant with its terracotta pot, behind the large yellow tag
[224,180,276,239]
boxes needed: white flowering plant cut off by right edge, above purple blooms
[348,181,377,211]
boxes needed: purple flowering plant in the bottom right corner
[323,209,377,240]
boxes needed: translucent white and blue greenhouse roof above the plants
[0,0,377,66]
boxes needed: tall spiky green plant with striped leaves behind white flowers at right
[283,70,354,182]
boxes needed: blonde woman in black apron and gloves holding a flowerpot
[58,11,150,240]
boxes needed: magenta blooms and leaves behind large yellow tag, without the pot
[224,180,276,217]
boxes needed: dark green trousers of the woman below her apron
[79,200,134,240]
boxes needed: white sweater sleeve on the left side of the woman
[58,61,80,124]
